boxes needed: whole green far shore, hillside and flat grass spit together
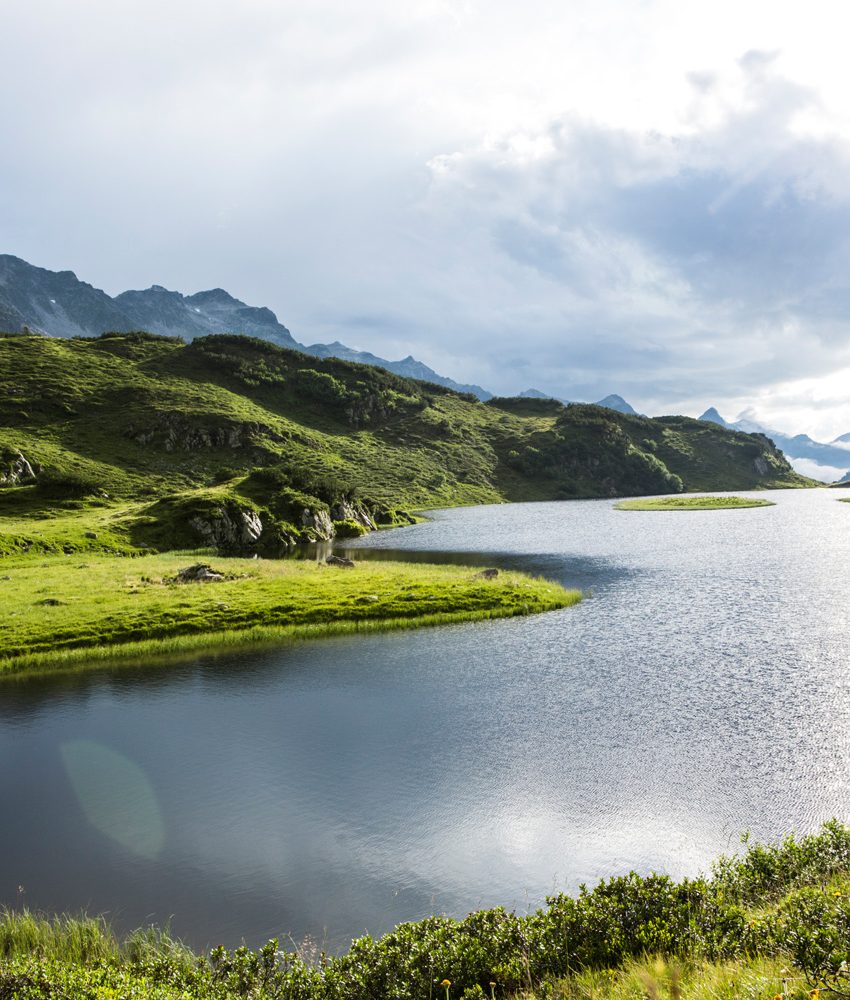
[0,333,808,674]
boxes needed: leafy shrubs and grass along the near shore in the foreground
[0,822,850,1000]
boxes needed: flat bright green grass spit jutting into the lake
[0,552,581,675]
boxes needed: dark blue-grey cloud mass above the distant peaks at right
[404,53,850,416]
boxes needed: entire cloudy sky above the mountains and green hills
[0,0,850,440]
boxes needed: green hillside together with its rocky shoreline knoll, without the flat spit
[0,333,808,554]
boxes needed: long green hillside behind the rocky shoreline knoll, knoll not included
[0,337,808,520]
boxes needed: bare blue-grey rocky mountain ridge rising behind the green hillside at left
[0,254,493,401]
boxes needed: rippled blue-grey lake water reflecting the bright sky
[0,490,850,949]
